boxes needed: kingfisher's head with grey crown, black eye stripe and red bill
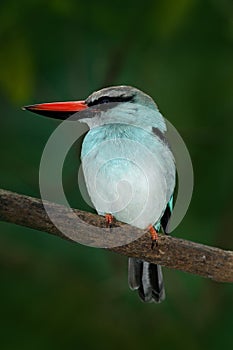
[23,85,166,131]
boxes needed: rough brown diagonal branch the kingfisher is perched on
[0,190,233,282]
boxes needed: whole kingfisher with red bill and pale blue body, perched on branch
[23,85,176,303]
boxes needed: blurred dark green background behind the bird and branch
[0,0,233,350]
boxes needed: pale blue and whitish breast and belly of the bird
[81,124,175,228]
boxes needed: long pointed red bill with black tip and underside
[22,101,88,119]
